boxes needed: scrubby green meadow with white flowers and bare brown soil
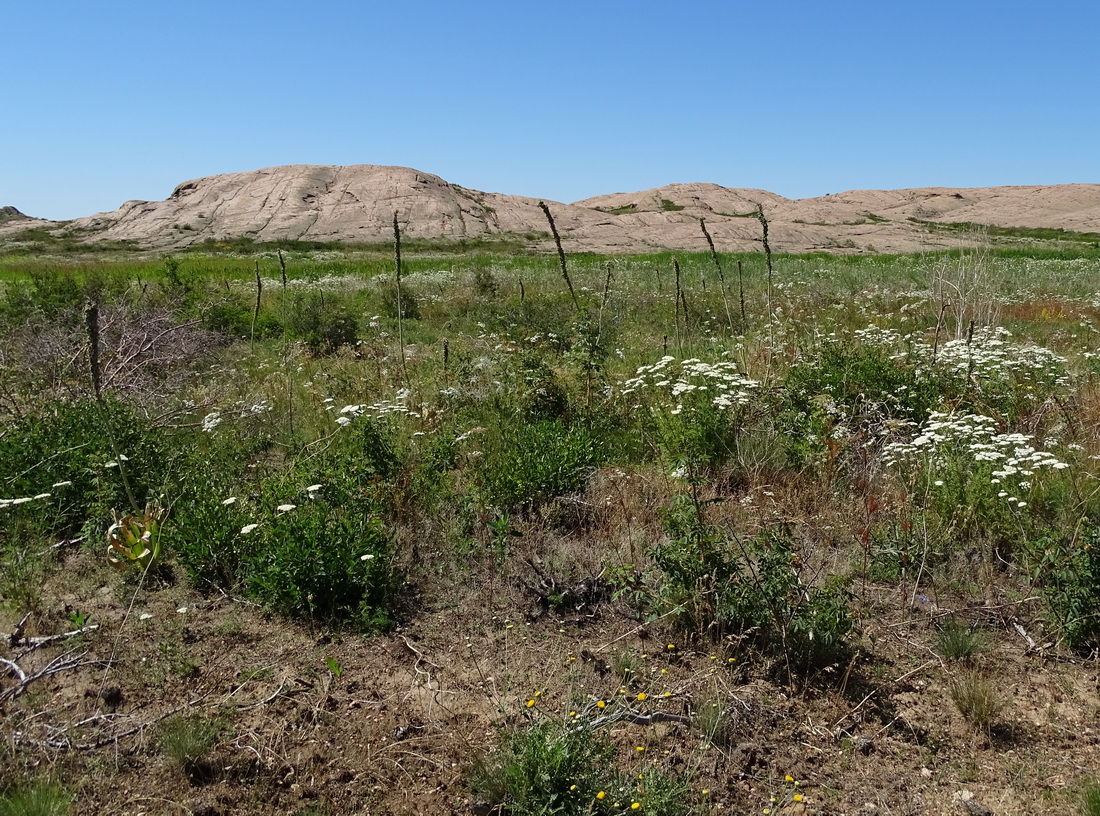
[0,242,1100,816]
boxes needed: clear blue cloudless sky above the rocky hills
[0,0,1100,219]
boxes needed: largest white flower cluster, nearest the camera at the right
[882,411,1069,507]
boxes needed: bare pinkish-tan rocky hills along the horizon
[0,165,1100,253]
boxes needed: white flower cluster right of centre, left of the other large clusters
[623,356,760,415]
